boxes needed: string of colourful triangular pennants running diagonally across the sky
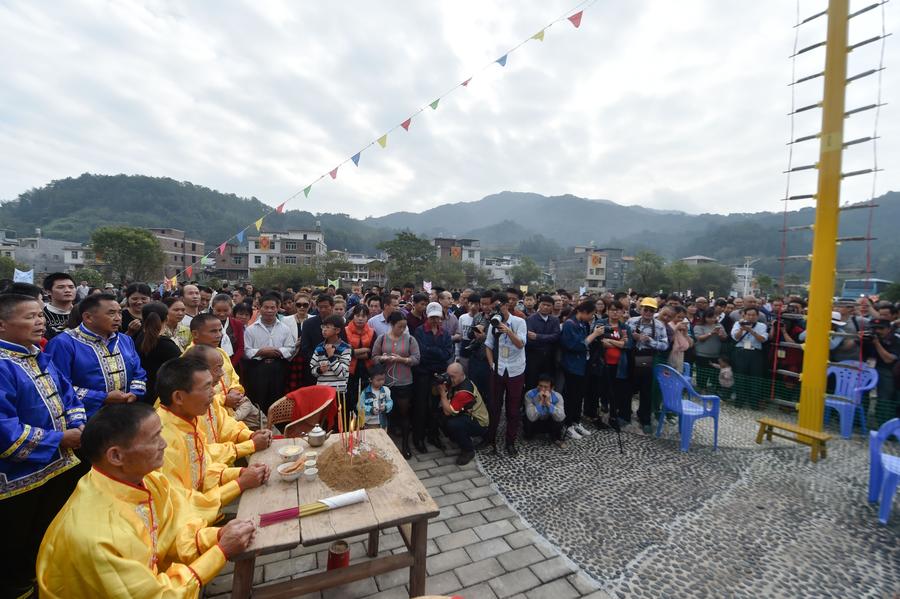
[163,0,597,283]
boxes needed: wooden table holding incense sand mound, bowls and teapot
[232,429,440,599]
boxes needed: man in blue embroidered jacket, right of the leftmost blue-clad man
[46,293,147,418]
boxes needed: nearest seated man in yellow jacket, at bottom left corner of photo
[37,403,255,599]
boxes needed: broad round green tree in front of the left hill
[91,227,165,283]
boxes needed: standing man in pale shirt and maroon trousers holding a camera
[485,292,528,456]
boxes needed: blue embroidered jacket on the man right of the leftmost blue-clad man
[45,324,147,418]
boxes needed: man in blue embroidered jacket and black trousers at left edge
[0,294,85,597]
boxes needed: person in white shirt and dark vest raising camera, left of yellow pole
[731,307,769,409]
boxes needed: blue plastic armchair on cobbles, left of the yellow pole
[654,364,721,451]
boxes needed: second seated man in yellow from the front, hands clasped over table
[156,358,269,522]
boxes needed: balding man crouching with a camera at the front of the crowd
[438,363,488,466]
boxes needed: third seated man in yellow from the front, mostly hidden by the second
[184,345,272,466]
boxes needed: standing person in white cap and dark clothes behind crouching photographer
[407,296,453,453]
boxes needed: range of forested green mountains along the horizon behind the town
[0,174,900,280]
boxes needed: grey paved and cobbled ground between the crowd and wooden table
[205,405,900,599]
